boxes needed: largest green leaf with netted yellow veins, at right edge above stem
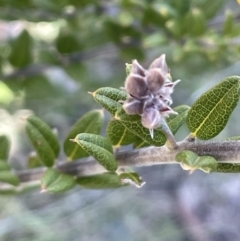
[187,76,240,140]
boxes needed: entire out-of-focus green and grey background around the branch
[0,0,240,241]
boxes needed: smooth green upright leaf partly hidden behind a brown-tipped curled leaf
[64,110,104,160]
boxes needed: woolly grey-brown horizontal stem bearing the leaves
[12,139,240,185]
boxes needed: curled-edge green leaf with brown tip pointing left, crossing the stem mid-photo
[74,133,118,171]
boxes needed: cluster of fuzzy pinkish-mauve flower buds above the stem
[123,54,180,138]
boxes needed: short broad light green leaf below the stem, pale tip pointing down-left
[41,168,76,193]
